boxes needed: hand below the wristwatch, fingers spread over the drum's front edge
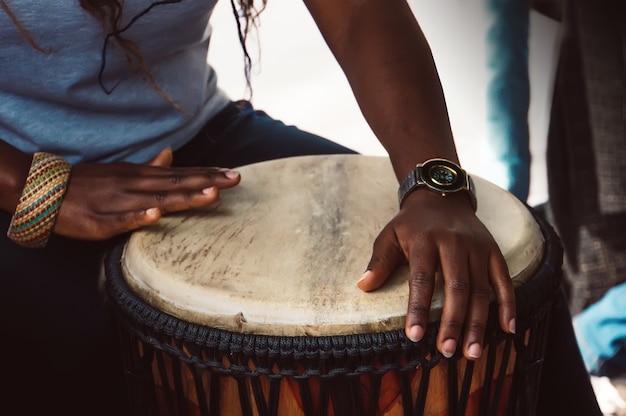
[358,189,515,360]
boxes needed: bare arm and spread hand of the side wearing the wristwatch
[305,0,515,359]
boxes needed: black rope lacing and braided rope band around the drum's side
[102,208,562,416]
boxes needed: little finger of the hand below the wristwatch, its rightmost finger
[489,251,516,334]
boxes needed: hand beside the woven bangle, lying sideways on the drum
[53,148,241,240]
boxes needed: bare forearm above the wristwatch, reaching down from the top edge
[306,0,458,179]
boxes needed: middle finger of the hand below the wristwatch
[437,243,470,358]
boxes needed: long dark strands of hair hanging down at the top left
[0,0,267,111]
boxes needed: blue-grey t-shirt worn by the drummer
[0,0,228,164]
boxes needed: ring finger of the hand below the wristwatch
[463,257,491,360]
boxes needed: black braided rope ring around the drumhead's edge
[105,207,563,375]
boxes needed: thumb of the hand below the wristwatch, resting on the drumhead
[357,226,405,292]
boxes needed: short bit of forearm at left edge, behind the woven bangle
[0,140,32,213]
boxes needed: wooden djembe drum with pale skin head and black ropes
[106,155,562,416]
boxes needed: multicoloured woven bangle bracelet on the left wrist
[7,152,72,248]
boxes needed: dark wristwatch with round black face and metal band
[398,159,476,212]
